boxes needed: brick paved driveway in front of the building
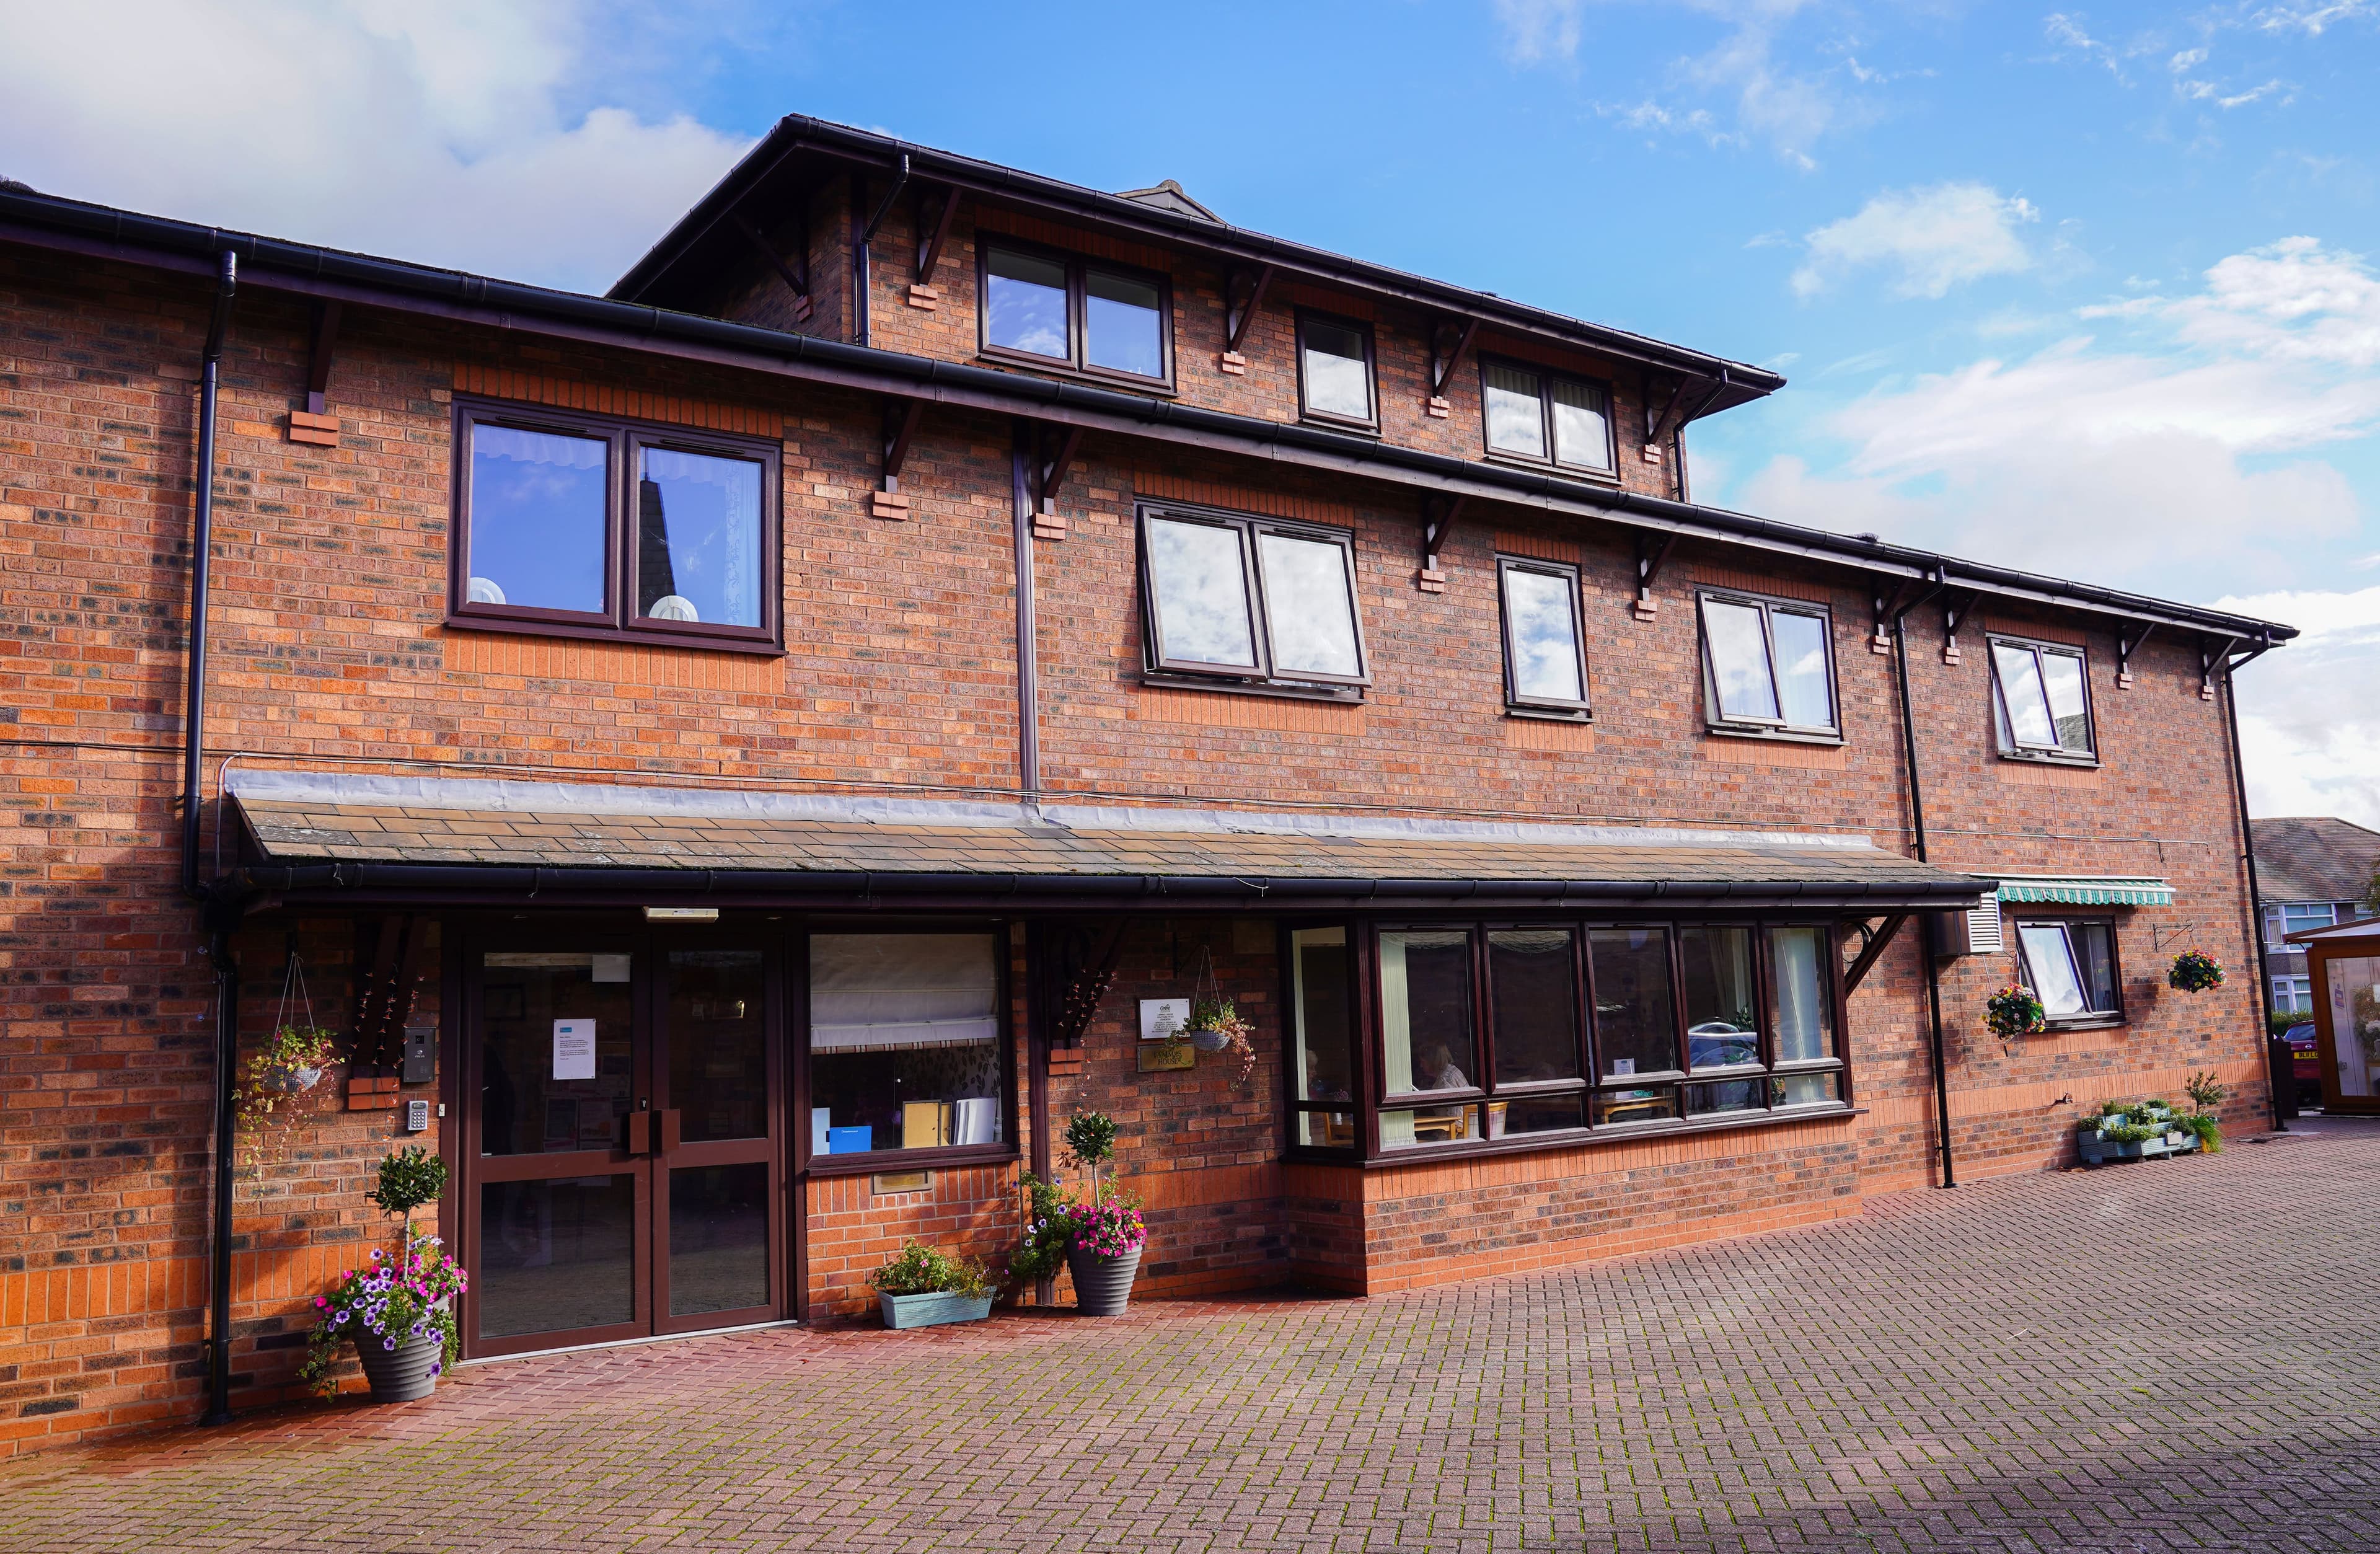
[0,1118,2380,1554]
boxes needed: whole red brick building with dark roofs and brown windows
[0,119,2292,1447]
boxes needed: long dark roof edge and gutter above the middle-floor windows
[0,190,2297,643]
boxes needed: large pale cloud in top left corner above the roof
[0,0,747,290]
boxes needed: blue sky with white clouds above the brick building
[0,0,2380,823]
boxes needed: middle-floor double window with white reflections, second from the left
[1140,507,1368,688]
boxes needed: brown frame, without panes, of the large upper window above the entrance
[445,395,785,655]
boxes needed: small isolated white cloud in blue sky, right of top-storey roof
[1792,183,2040,298]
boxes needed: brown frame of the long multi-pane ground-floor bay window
[1323,911,1854,1166]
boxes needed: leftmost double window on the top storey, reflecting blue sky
[981,245,1173,383]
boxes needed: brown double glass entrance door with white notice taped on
[462,938,793,1354]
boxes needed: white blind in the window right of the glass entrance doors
[809,933,1000,1052]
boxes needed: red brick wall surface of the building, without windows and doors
[0,233,2263,1447]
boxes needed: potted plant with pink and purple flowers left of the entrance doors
[298,1145,469,1404]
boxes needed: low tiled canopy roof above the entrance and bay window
[226,771,1987,911]
